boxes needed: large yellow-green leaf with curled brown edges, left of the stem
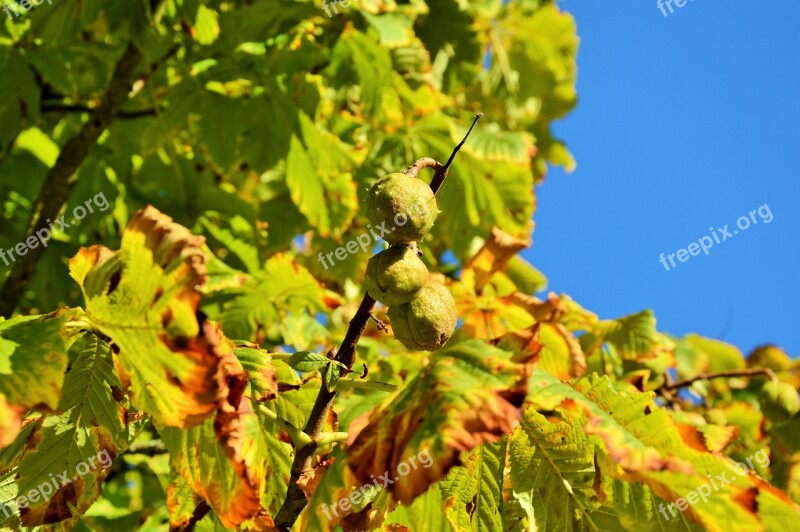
[70,207,238,427]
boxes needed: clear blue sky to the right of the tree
[525,0,800,356]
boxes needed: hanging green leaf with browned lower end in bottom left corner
[0,334,127,526]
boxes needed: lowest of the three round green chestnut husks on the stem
[389,282,458,351]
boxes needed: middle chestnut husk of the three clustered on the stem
[364,245,428,307]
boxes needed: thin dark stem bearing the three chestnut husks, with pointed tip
[275,114,483,531]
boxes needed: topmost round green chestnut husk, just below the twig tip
[367,172,439,244]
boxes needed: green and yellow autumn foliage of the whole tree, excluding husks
[0,0,800,531]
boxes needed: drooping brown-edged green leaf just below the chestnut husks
[348,340,524,510]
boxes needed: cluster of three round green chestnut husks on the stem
[365,173,458,351]
